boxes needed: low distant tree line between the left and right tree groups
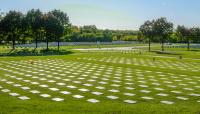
[64,25,138,42]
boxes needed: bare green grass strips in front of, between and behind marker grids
[0,45,200,114]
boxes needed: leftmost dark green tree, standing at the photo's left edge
[1,11,23,49]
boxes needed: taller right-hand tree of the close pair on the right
[154,17,173,51]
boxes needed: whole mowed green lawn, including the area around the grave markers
[0,45,200,114]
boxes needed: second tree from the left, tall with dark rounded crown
[24,9,44,48]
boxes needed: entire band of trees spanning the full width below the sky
[0,9,200,51]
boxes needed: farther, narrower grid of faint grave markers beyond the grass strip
[78,56,200,72]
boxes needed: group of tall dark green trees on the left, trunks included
[0,9,70,50]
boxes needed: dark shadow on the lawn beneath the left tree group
[0,49,73,56]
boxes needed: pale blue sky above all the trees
[0,0,200,30]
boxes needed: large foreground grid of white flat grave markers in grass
[0,58,200,104]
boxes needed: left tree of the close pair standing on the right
[140,20,155,51]
